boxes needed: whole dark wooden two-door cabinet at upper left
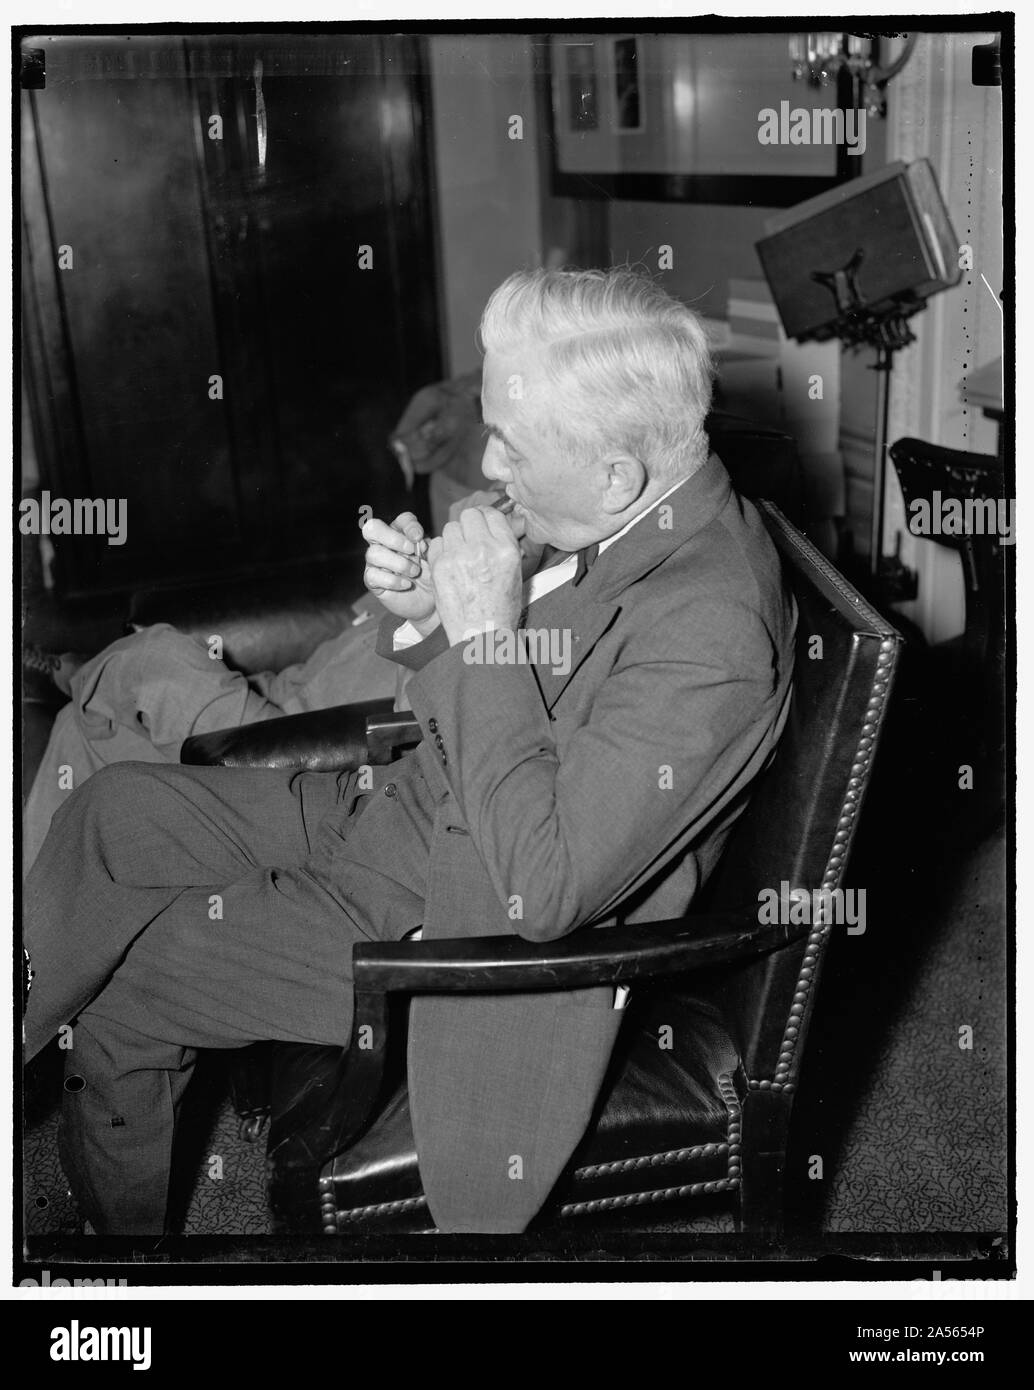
[21,33,441,595]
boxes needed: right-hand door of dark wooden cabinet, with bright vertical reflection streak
[188,35,439,569]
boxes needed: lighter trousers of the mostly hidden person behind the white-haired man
[24,605,397,873]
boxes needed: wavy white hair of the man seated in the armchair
[479,270,714,481]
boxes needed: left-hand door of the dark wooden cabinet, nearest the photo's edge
[22,39,242,592]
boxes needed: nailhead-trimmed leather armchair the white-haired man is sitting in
[183,502,901,1237]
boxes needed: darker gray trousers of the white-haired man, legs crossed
[25,763,425,1234]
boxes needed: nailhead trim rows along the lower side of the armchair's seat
[320,1072,742,1236]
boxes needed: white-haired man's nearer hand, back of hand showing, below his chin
[428,507,521,645]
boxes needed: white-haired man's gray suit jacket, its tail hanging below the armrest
[381,456,795,1232]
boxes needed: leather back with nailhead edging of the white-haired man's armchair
[702,502,902,1090]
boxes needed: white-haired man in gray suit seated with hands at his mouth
[25,271,795,1233]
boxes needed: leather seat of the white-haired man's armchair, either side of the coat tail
[320,984,746,1232]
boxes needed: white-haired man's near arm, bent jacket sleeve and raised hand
[409,512,785,940]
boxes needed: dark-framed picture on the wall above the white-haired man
[543,33,864,207]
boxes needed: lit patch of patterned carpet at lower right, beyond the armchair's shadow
[823,822,1008,1232]
